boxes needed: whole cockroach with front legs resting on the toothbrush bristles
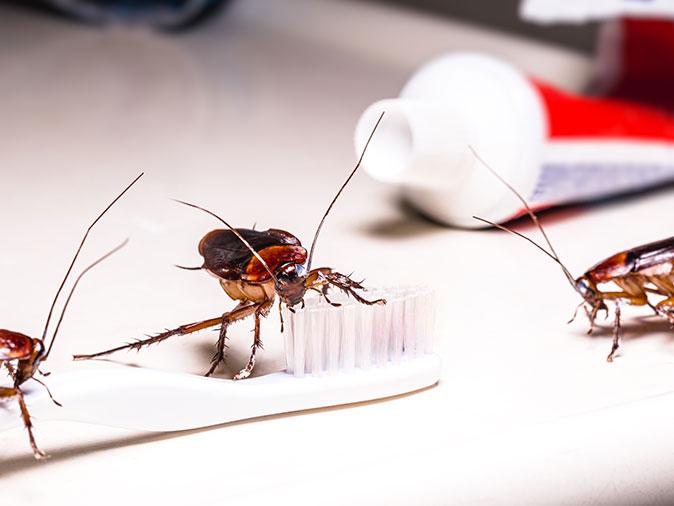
[73,113,386,380]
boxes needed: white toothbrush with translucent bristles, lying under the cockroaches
[0,287,440,431]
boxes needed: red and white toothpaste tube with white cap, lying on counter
[355,53,674,228]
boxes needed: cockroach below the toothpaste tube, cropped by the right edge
[470,148,674,362]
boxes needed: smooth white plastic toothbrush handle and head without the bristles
[0,355,440,431]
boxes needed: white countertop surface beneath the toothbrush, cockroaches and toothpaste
[0,0,674,505]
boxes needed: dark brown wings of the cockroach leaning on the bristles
[199,228,301,280]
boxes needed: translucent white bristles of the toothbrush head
[284,287,435,376]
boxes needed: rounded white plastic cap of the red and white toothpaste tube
[355,53,547,228]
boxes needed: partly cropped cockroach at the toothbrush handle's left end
[0,173,143,459]
